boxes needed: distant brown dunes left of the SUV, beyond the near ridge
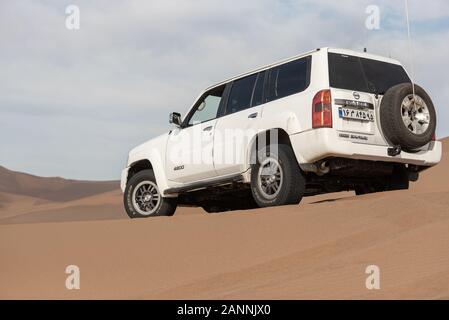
[0,166,123,224]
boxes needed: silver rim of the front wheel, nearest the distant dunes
[132,181,161,216]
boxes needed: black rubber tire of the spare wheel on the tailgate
[379,83,437,151]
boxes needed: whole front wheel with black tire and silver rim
[123,170,177,219]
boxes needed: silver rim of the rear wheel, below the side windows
[257,157,284,200]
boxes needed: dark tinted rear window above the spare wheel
[329,53,410,94]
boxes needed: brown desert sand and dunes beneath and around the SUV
[0,139,449,299]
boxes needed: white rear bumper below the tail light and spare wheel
[290,128,442,166]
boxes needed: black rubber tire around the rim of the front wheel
[123,170,178,219]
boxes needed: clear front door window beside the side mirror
[188,86,225,126]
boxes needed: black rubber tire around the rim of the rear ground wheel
[251,144,306,207]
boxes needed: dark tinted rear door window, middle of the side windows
[226,74,257,114]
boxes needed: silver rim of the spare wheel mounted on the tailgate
[401,94,430,135]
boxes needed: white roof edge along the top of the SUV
[204,47,401,92]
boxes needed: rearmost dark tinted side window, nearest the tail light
[268,56,311,101]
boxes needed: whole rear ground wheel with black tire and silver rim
[251,144,306,207]
